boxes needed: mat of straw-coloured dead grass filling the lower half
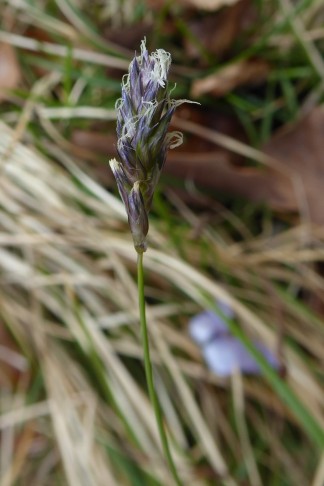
[0,117,324,486]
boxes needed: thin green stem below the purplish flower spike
[137,253,182,486]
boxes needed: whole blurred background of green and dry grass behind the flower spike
[0,0,324,486]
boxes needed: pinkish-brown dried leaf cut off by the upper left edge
[0,43,21,101]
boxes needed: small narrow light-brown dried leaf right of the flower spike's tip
[191,60,269,98]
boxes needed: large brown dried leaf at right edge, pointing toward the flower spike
[166,107,324,225]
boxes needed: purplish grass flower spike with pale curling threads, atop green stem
[110,40,186,253]
